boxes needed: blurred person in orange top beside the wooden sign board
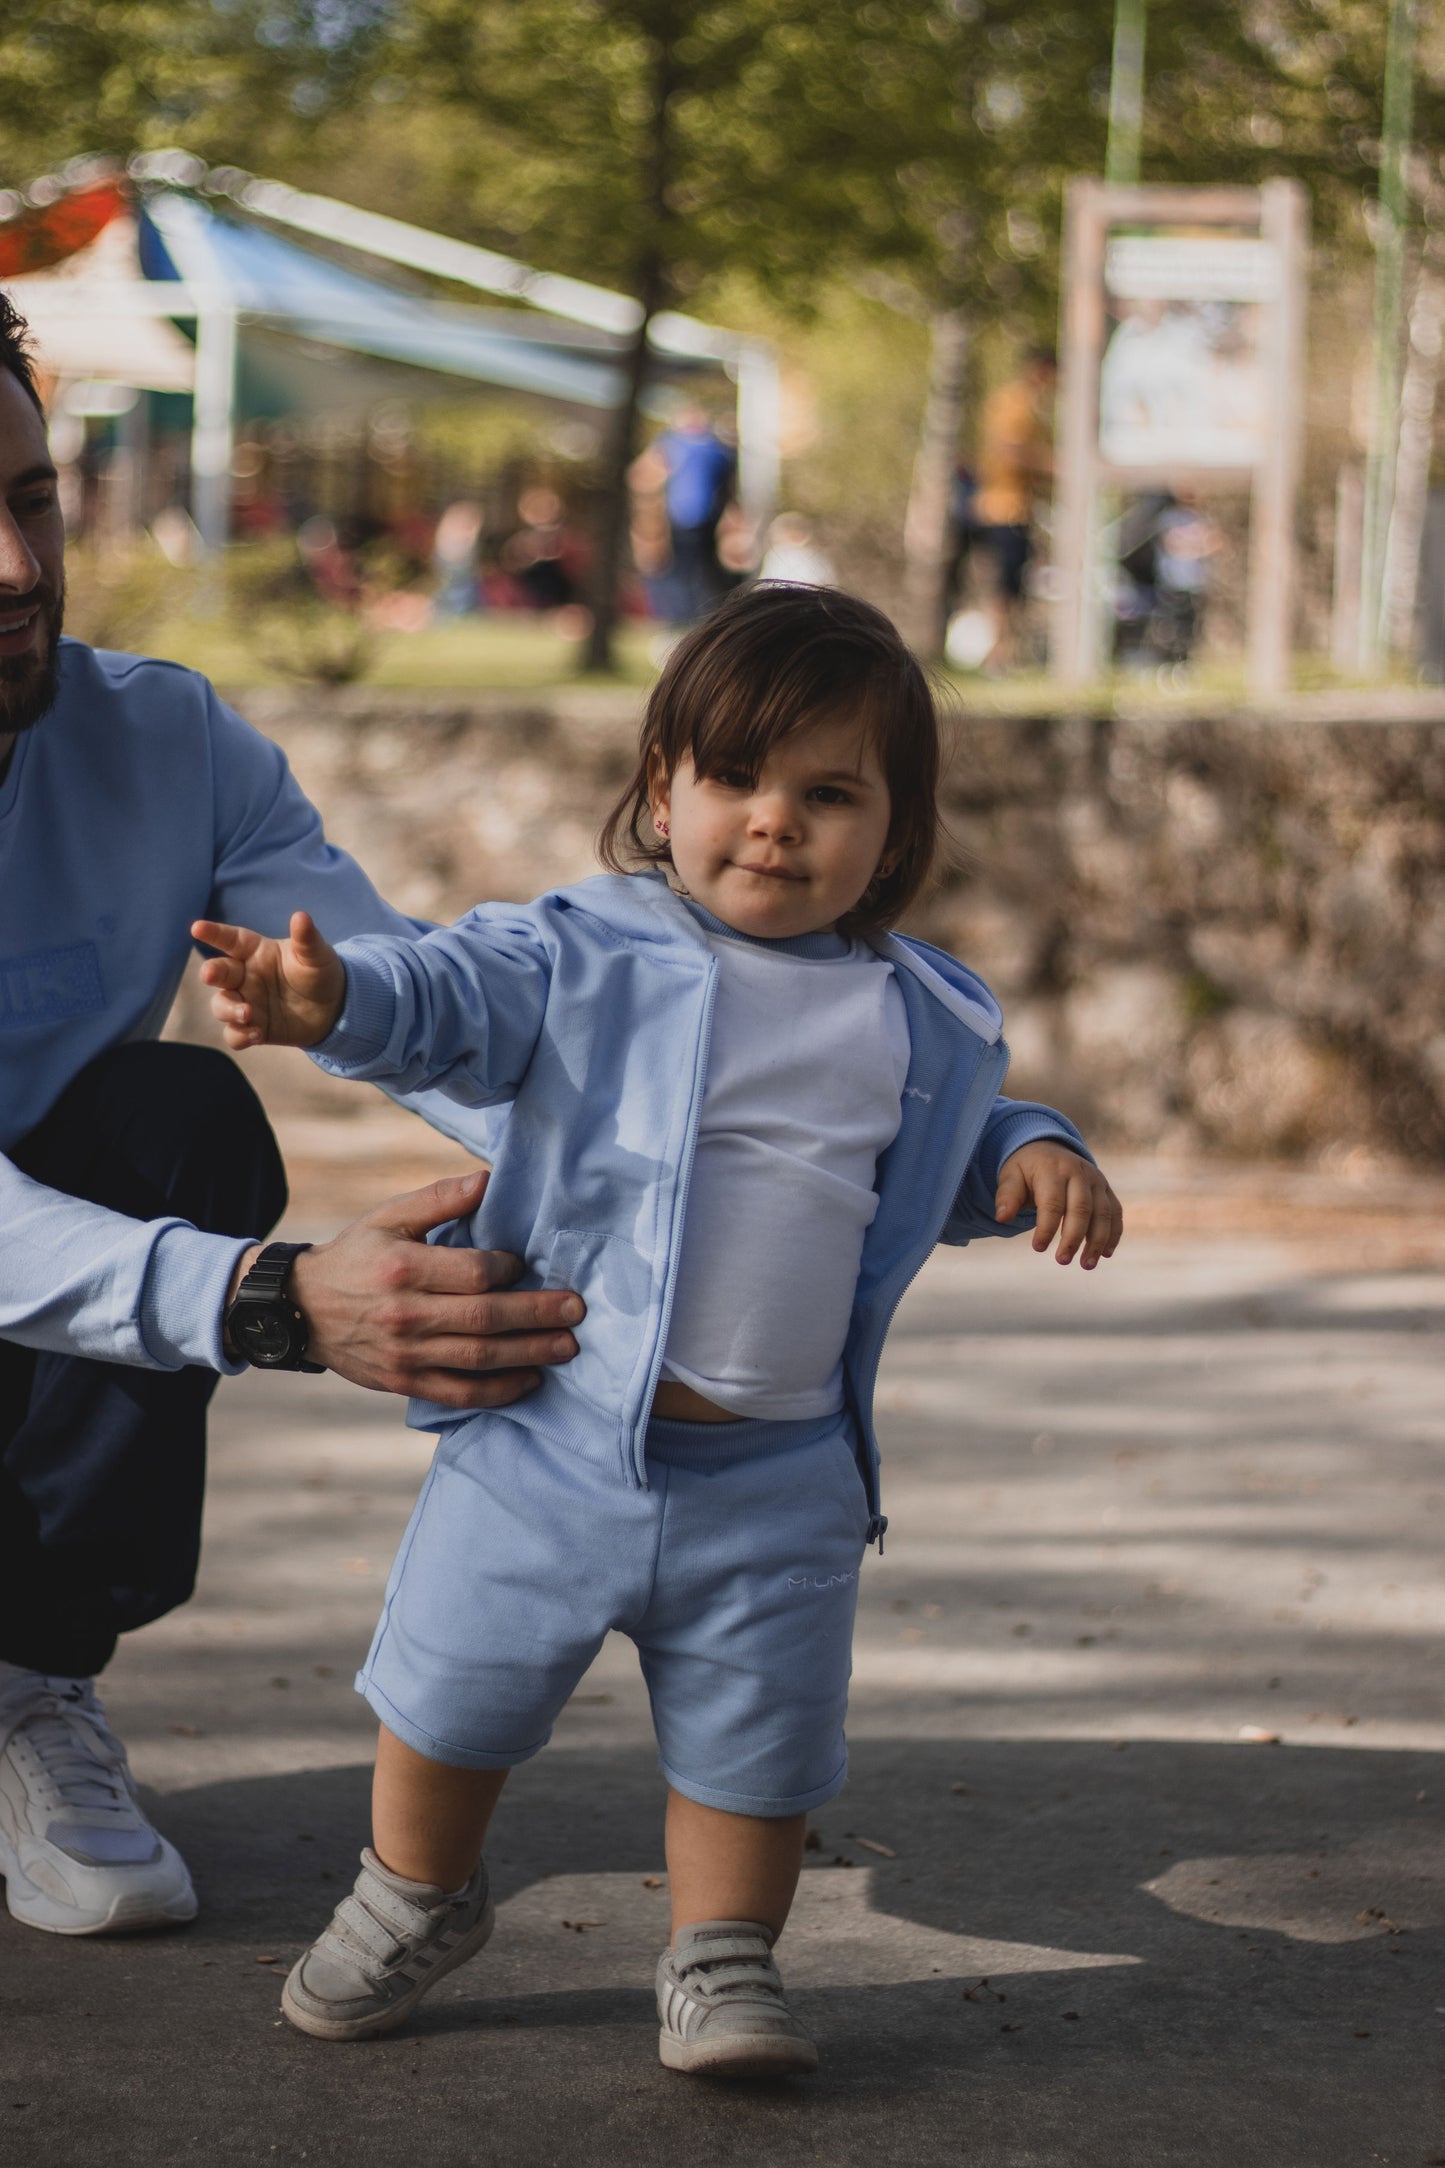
[973,347,1057,670]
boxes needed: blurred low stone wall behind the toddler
[226,689,1445,1162]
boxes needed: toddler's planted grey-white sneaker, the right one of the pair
[656,1919,817,2077]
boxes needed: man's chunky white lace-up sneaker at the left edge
[0,1663,195,1934]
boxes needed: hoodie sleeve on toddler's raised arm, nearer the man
[312,904,552,1108]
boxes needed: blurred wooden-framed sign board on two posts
[1051,180,1309,698]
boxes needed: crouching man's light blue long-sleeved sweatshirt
[0,640,437,1370]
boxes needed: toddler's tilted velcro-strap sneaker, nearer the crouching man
[282,1849,496,2040]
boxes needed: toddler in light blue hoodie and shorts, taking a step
[193,583,1122,2075]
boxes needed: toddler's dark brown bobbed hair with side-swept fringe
[598,581,940,928]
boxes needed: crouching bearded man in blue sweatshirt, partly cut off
[0,295,581,1934]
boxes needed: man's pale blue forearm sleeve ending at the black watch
[0,1156,249,1375]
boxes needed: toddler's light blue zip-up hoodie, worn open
[312,874,1085,1533]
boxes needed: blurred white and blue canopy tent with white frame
[0,152,778,549]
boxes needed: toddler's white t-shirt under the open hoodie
[663,913,910,1420]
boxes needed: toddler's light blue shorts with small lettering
[357,1411,869,1815]
